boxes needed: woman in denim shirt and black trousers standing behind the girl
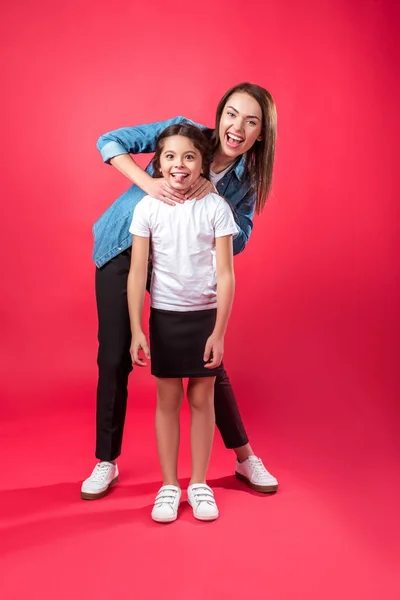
[81,83,278,500]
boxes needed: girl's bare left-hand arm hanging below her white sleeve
[128,235,150,367]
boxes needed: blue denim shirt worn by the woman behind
[93,117,255,267]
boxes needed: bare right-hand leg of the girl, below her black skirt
[187,377,215,485]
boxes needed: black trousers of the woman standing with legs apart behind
[96,249,248,461]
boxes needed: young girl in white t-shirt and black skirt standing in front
[128,125,237,523]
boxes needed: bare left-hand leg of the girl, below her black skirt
[156,377,183,487]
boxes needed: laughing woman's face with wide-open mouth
[219,92,263,159]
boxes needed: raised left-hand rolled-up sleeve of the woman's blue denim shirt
[97,117,200,163]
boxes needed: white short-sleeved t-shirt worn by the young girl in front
[129,194,238,311]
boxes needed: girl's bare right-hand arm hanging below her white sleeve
[204,235,235,369]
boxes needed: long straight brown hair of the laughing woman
[212,82,277,213]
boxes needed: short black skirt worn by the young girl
[150,308,222,378]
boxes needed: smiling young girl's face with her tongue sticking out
[160,135,203,192]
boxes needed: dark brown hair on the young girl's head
[152,124,211,179]
